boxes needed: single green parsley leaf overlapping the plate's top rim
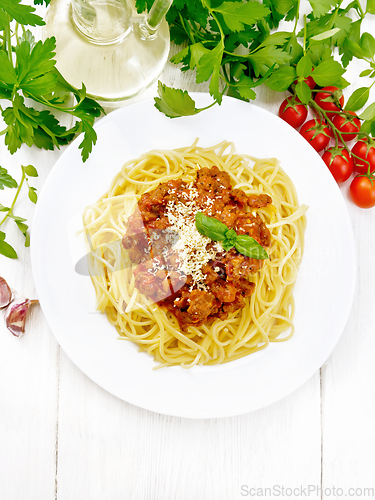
[155,81,199,118]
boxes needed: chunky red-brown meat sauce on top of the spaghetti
[122,166,272,331]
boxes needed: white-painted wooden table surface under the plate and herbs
[0,1,375,500]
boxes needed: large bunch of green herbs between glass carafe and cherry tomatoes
[136,0,375,136]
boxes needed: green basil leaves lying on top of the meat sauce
[195,212,268,260]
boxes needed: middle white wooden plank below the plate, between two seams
[57,353,321,500]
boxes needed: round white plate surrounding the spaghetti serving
[31,94,356,418]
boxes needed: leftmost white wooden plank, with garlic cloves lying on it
[0,146,65,500]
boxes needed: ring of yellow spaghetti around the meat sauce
[83,141,307,368]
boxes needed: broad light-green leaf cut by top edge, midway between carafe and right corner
[212,0,270,31]
